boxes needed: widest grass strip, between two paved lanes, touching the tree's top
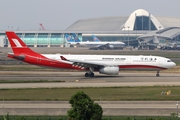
[0,86,180,101]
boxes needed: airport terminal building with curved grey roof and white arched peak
[0,9,180,47]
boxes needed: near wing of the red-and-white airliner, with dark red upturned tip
[60,56,105,68]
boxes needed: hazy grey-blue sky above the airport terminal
[0,0,180,30]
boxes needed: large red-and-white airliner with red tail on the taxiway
[6,31,176,77]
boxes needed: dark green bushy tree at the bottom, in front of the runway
[68,92,103,120]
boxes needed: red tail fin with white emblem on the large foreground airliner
[6,31,36,55]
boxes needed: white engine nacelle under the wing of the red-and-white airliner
[99,66,119,75]
